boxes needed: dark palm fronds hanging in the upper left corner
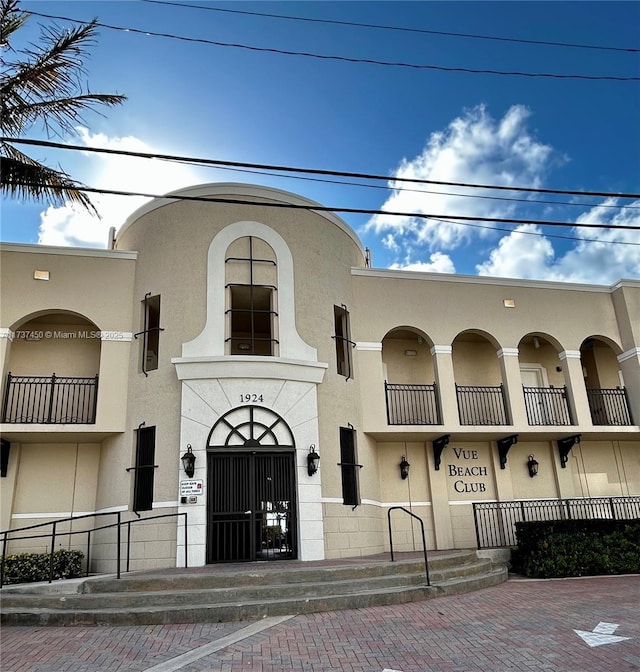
[0,0,126,215]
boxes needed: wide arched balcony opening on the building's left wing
[2,311,101,424]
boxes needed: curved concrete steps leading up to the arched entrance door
[0,551,507,625]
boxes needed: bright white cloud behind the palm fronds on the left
[38,128,205,247]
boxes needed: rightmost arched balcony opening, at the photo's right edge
[580,336,633,426]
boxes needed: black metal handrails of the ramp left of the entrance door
[0,511,189,588]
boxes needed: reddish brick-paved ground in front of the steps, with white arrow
[0,576,640,672]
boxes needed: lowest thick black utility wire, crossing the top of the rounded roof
[12,182,640,232]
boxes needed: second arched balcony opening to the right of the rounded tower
[452,330,511,425]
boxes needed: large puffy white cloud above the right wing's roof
[367,105,553,258]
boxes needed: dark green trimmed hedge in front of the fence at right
[512,519,640,578]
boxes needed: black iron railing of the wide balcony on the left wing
[2,373,98,425]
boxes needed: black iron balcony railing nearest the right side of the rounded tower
[384,381,442,425]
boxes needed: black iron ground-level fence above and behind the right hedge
[473,496,640,548]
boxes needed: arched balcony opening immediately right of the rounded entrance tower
[382,327,442,425]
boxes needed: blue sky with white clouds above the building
[1,0,640,284]
